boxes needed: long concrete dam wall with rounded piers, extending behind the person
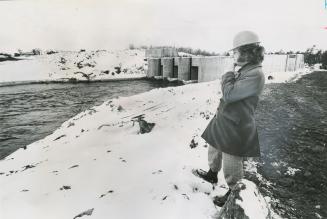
[148,54,304,82]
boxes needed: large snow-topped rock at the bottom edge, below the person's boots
[214,179,272,219]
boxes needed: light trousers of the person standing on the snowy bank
[208,145,244,189]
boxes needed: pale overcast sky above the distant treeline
[0,0,327,53]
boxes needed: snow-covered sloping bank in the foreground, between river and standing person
[0,64,307,219]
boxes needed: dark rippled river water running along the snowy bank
[0,80,176,159]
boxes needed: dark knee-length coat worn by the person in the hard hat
[201,64,265,157]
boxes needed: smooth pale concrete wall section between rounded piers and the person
[192,56,233,82]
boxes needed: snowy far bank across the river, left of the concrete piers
[0,50,147,82]
